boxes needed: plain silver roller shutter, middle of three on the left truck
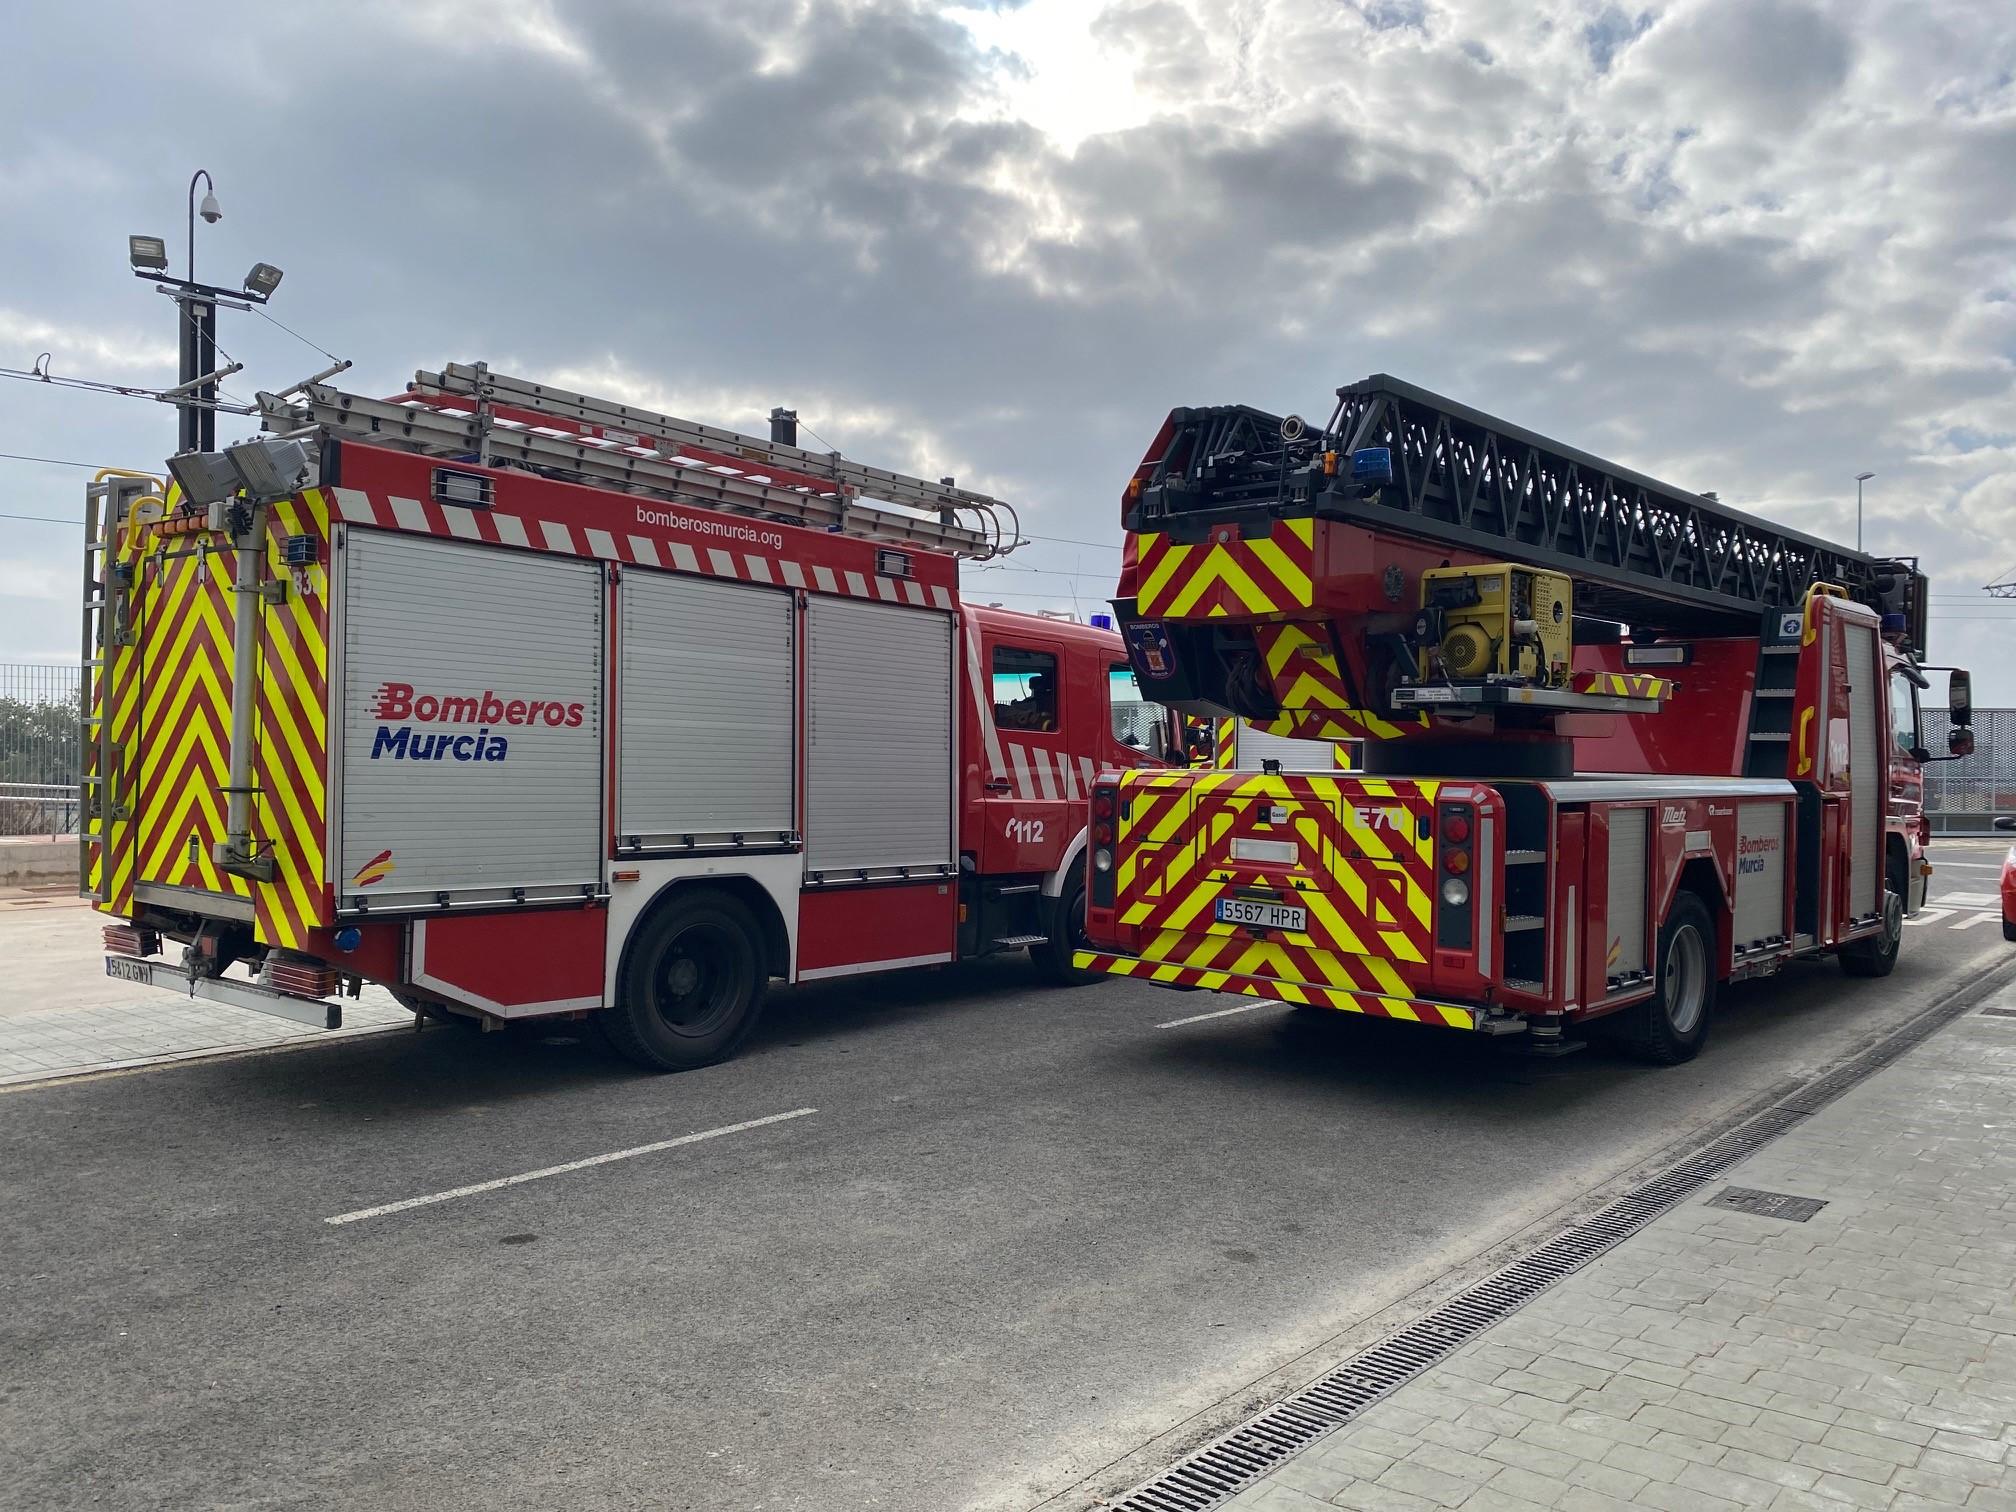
[617,571,794,849]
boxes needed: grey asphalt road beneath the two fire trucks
[0,845,2016,1512]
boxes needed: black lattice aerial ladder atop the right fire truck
[1322,373,1927,647]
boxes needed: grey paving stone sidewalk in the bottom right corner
[1226,994,2016,1512]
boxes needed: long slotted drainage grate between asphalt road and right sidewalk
[1103,962,2016,1512]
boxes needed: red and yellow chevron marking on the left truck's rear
[93,490,329,948]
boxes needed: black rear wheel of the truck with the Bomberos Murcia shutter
[595,889,770,1070]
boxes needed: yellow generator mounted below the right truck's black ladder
[1415,562,1574,687]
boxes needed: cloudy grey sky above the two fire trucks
[0,0,2016,704]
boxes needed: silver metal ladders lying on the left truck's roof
[260,363,1020,560]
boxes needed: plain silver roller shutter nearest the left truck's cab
[804,595,958,883]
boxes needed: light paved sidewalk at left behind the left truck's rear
[0,893,413,1089]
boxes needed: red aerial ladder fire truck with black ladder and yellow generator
[1077,375,1972,1062]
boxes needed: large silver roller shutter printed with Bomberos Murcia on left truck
[333,530,603,909]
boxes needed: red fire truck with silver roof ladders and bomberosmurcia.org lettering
[85,365,1171,1068]
